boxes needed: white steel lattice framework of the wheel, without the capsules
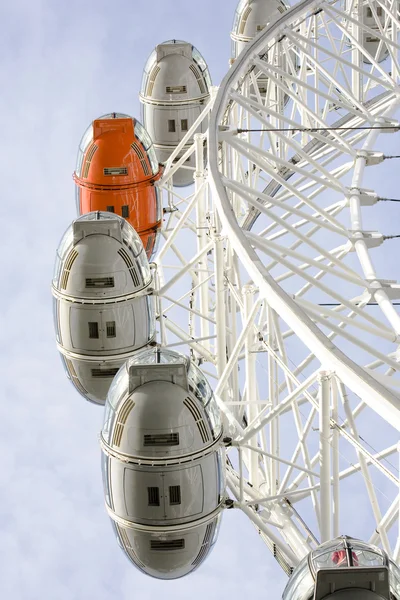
[155,0,400,574]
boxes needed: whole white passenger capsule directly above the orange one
[140,40,211,186]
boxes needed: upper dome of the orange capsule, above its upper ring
[74,113,160,186]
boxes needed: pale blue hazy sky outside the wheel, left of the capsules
[0,0,286,600]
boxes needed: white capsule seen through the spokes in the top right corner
[344,0,399,64]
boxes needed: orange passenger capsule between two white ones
[73,113,162,259]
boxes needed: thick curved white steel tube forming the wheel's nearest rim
[208,0,400,430]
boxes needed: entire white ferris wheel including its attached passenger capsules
[53,0,400,584]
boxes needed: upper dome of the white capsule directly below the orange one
[53,212,152,299]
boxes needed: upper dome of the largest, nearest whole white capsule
[102,349,222,459]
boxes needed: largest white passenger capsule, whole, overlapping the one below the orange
[101,349,225,579]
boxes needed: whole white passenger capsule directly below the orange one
[52,212,155,404]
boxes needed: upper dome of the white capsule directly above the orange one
[140,40,211,103]
